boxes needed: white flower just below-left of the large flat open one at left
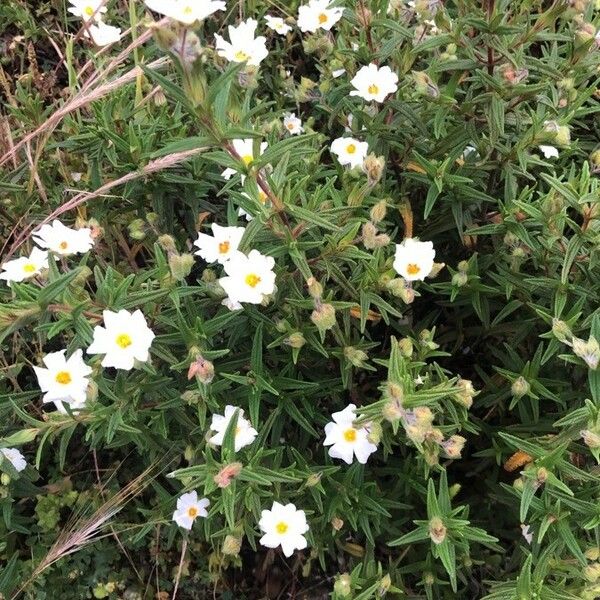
[33,350,92,413]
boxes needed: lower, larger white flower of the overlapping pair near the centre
[219,250,275,304]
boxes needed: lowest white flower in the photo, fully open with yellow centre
[258,502,308,557]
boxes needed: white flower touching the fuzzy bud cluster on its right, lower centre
[323,404,377,465]
